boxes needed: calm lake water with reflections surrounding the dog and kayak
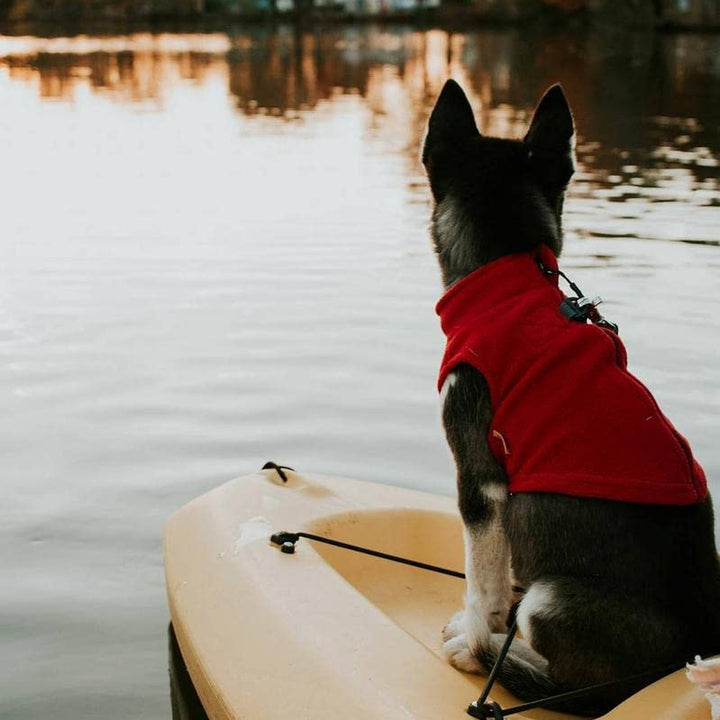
[0,26,720,720]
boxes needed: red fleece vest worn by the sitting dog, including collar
[437,245,707,505]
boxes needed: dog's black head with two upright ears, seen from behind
[422,80,575,287]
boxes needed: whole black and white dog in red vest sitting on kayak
[422,80,720,716]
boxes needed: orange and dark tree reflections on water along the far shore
[0,27,720,241]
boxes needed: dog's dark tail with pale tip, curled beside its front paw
[478,634,619,717]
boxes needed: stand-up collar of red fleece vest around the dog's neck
[435,244,560,335]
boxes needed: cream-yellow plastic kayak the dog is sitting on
[165,470,710,720]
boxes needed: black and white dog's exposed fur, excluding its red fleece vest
[422,80,720,716]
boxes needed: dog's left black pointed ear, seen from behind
[422,80,480,200]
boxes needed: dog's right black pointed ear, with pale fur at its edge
[525,85,575,188]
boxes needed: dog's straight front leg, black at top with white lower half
[443,365,512,672]
